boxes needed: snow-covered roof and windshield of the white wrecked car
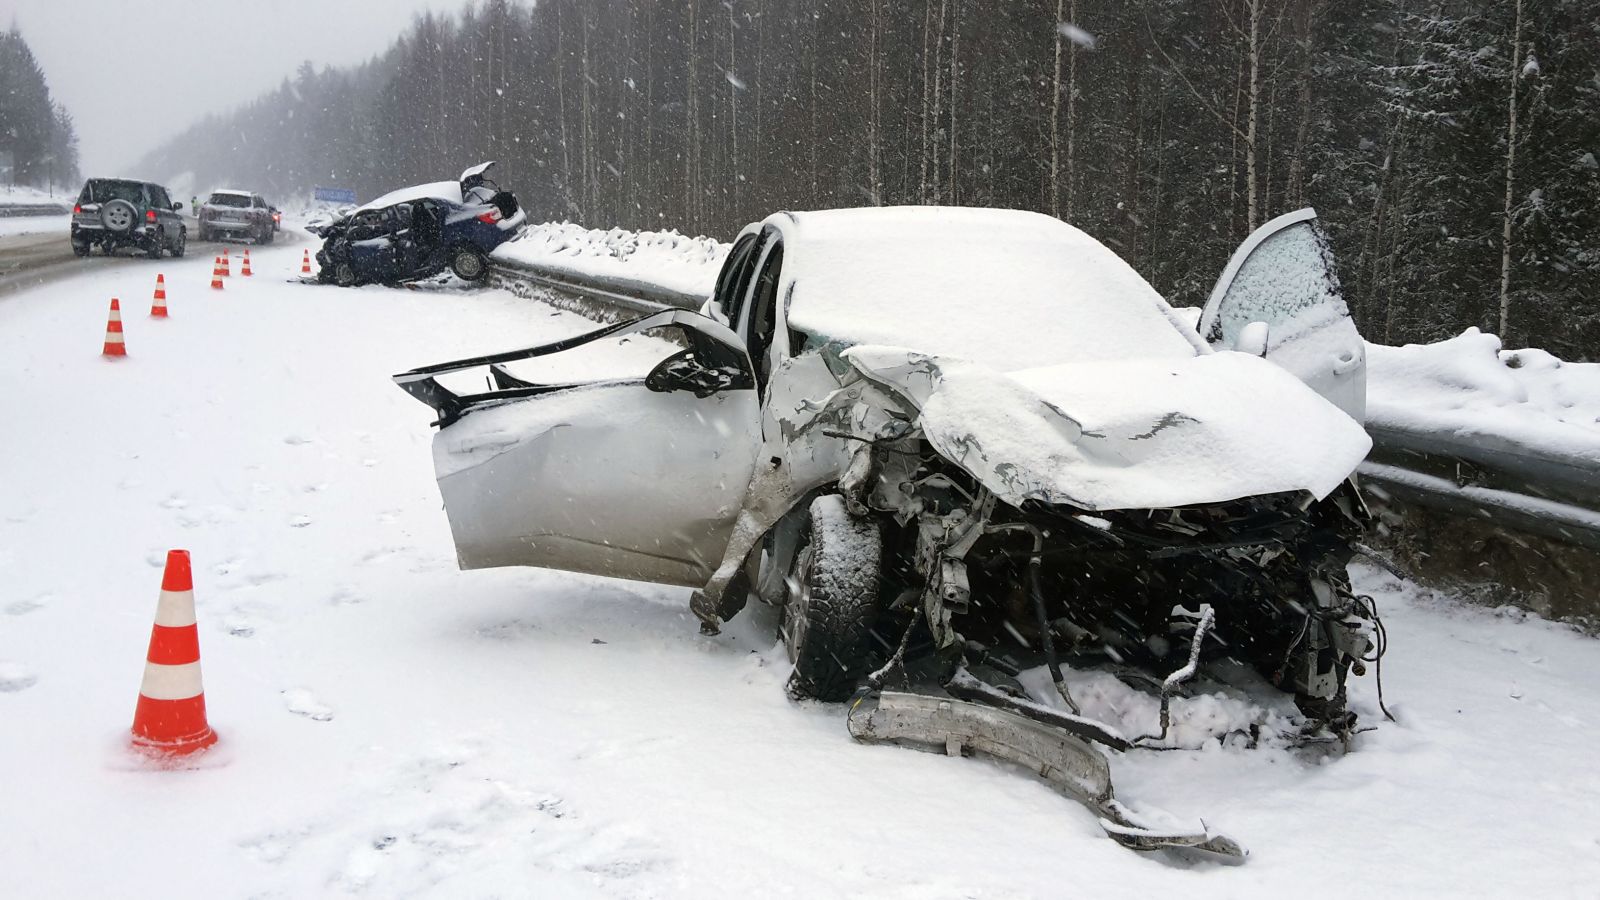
[765,207,1206,372]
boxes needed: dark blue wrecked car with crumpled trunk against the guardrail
[312,162,526,287]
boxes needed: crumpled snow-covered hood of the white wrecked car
[843,346,1371,509]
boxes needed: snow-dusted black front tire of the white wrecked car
[779,493,883,703]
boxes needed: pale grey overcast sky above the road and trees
[10,0,469,178]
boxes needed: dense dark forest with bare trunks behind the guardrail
[139,0,1600,360]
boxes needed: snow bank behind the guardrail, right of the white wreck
[1366,328,1600,466]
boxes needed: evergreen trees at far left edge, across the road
[0,24,80,192]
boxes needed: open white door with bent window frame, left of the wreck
[395,309,760,586]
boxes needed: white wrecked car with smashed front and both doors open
[395,207,1373,730]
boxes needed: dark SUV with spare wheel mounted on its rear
[72,178,189,259]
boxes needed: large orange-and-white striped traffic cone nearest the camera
[133,549,216,756]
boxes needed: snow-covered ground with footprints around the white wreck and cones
[0,245,1600,898]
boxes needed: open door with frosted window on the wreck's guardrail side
[1200,208,1366,423]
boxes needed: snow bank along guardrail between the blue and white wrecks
[494,223,730,298]
